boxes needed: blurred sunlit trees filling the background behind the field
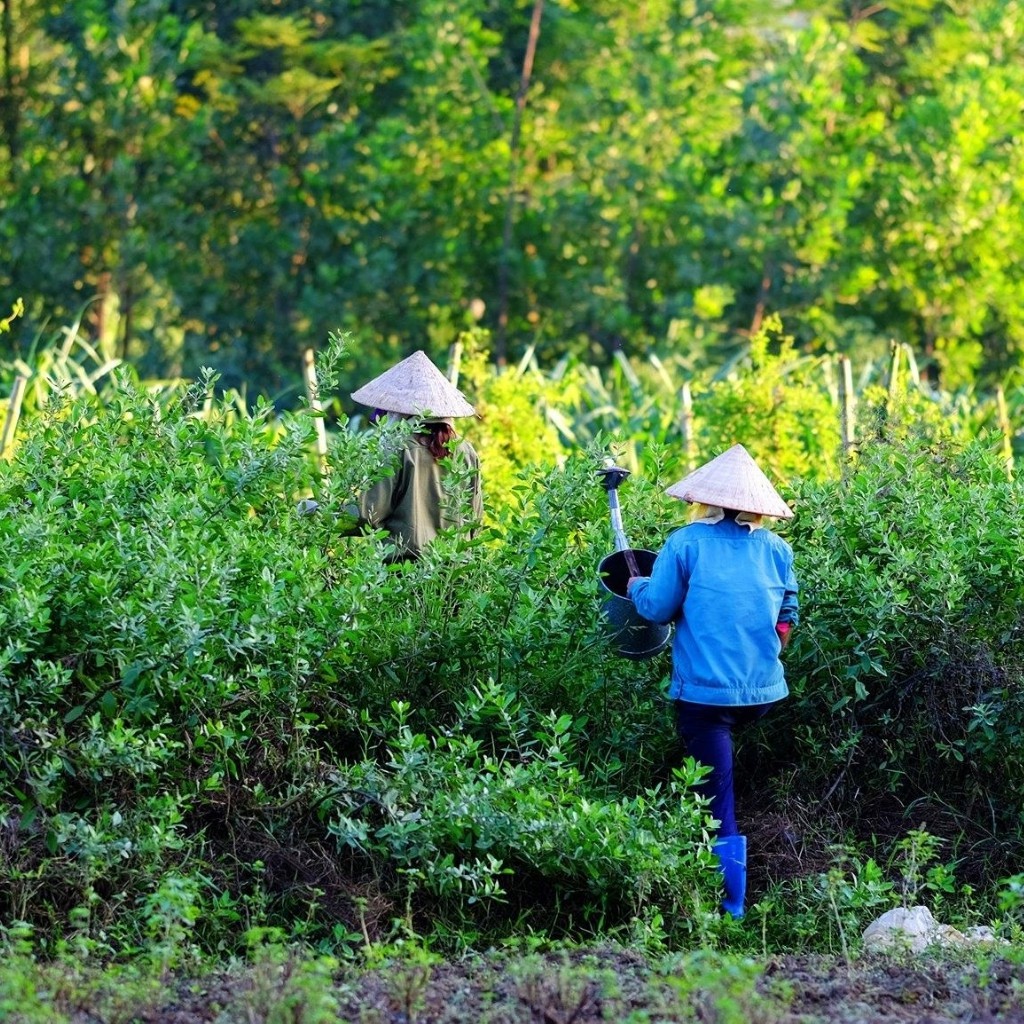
[0,0,1024,393]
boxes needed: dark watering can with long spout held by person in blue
[598,465,672,662]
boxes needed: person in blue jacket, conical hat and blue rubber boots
[627,444,798,918]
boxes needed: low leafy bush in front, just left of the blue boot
[319,686,712,942]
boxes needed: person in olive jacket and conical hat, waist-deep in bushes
[352,351,483,560]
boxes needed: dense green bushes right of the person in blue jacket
[783,423,1024,824]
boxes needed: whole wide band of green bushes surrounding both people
[6,307,1024,968]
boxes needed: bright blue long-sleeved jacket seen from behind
[629,519,799,706]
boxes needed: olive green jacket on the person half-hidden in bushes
[359,437,483,558]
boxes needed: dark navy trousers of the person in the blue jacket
[676,700,777,837]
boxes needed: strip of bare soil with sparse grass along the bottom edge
[0,943,1024,1024]
